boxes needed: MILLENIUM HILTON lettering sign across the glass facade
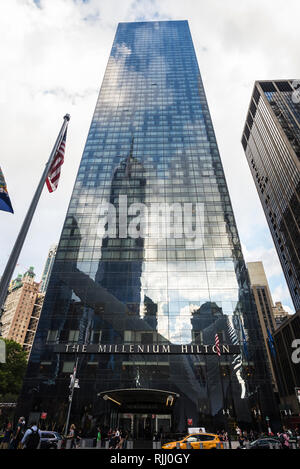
[54,344,240,355]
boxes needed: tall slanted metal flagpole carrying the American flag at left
[0,114,70,318]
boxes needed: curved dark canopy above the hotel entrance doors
[98,388,179,410]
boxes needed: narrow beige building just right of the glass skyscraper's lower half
[247,262,278,391]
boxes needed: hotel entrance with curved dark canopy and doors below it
[98,389,179,440]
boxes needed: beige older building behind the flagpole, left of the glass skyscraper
[1,267,44,356]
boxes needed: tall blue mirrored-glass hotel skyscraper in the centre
[20,21,275,438]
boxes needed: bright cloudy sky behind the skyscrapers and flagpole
[0,0,300,312]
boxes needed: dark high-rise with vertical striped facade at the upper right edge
[242,80,300,311]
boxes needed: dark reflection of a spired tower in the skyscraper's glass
[95,138,146,316]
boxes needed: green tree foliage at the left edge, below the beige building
[0,339,27,400]
